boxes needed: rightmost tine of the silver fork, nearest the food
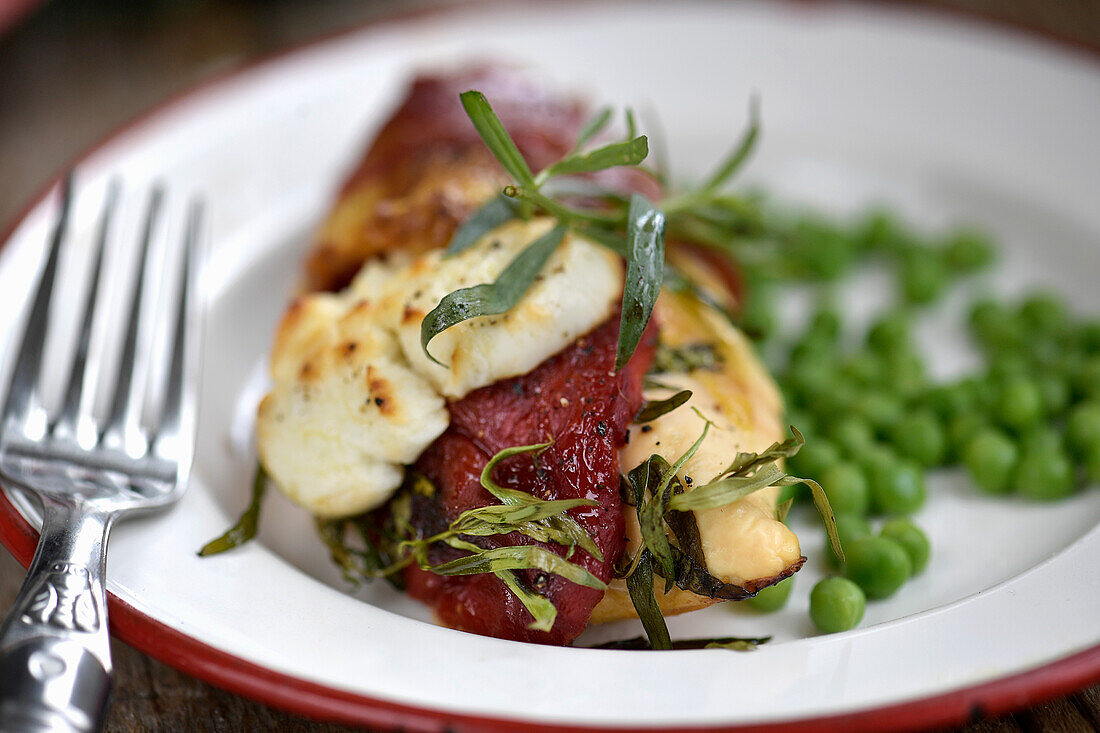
[153,200,204,464]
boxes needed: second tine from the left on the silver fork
[54,180,119,448]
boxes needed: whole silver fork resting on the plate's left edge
[0,174,202,733]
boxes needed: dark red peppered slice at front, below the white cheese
[405,312,657,644]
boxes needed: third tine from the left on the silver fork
[102,186,164,455]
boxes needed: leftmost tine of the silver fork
[3,171,73,431]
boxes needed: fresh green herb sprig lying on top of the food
[420,90,761,370]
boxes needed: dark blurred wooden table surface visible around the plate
[0,0,1100,733]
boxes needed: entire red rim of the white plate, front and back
[0,0,1100,733]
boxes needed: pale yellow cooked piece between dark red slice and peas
[592,293,805,623]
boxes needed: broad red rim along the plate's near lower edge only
[0,490,1100,733]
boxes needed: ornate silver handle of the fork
[0,496,113,733]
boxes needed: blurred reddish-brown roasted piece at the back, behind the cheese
[306,67,659,290]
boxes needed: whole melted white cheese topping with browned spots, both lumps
[256,220,623,517]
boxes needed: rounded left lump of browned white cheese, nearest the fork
[256,279,448,516]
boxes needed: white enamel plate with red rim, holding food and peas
[0,3,1100,729]
